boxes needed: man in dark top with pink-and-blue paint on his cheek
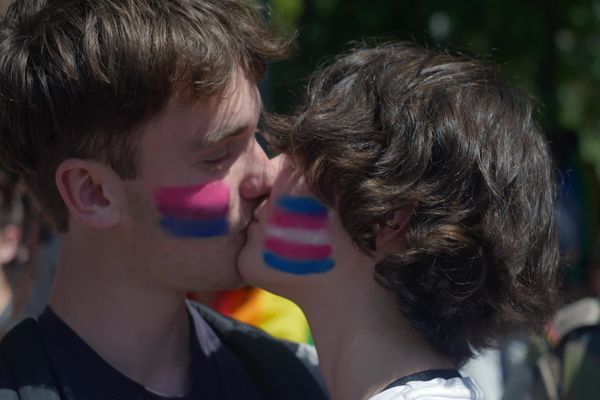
[0,0,325,400]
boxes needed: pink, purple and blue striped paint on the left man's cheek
[155,181,229,238]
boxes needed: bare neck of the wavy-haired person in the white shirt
[298,268,454,400]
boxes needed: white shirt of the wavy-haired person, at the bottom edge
[369,378,484,400]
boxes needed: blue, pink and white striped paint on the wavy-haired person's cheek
[263,196,335,275]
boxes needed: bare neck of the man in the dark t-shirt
[50,231,190,396]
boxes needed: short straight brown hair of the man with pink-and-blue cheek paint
[0,0,289,230]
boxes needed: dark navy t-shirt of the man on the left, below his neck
[39,307,265,400]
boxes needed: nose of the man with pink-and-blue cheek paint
[240,142,279,200]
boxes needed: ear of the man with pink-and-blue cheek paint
[55,159,121,229]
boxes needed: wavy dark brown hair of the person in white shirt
[266,43,558,364]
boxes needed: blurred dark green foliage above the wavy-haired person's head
[263,0,600,175]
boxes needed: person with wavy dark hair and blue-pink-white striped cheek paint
[239,43,558,400]
